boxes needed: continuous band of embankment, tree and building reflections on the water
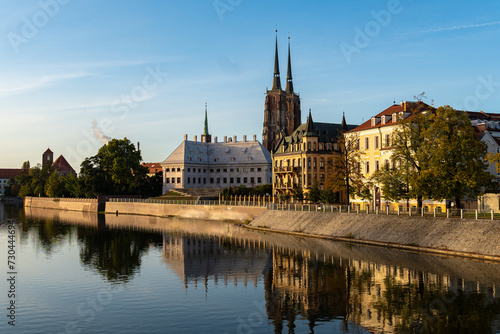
[22,209,500,333]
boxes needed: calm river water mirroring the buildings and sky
[0,203,500,333]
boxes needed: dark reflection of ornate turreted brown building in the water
[266,250,347,333]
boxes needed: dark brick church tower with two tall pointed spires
[262,34,301,152]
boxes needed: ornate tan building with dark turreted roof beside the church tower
[272,111,356,200]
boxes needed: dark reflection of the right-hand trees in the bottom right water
[374,275,500,334]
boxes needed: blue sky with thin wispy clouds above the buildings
[0,0,500,172]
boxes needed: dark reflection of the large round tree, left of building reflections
[78,228,162,282]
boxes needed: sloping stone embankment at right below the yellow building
[249,211,500,260]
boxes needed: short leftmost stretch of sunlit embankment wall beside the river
[24,197,97,212]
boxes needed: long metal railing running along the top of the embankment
[109,198,500,220]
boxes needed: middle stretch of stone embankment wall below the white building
[106,202,266,221]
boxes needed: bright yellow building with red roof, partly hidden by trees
[349,101,446,212]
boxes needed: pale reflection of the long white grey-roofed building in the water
[163,233,270,288]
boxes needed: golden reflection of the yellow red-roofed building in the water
[347,260,500,333]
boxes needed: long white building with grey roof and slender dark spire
[161,109,272,193]
